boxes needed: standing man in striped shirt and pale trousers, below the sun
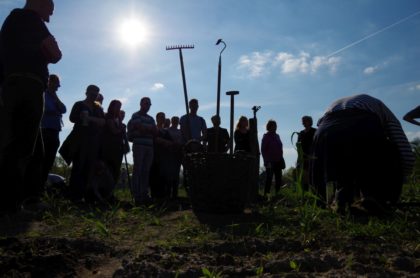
[127,97,157,205]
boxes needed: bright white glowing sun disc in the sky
[119,18,147,48]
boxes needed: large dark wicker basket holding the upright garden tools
[184,153,255,213]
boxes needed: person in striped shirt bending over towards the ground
[311,94,415,212]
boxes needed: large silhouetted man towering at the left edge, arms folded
[0,0,62,210]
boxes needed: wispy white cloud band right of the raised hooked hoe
[238,51,341,78]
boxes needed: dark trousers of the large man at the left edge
[0,77,44,208]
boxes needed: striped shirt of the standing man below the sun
[127,111,156,147]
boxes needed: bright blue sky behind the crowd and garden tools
[0,0,420,167]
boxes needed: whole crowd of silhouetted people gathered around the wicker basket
[0,0,420,215]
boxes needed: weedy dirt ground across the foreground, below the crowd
[0,184,420,277]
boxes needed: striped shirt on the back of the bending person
[318,94,415,177]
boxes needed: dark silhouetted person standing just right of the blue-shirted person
[64,85,105,201]
